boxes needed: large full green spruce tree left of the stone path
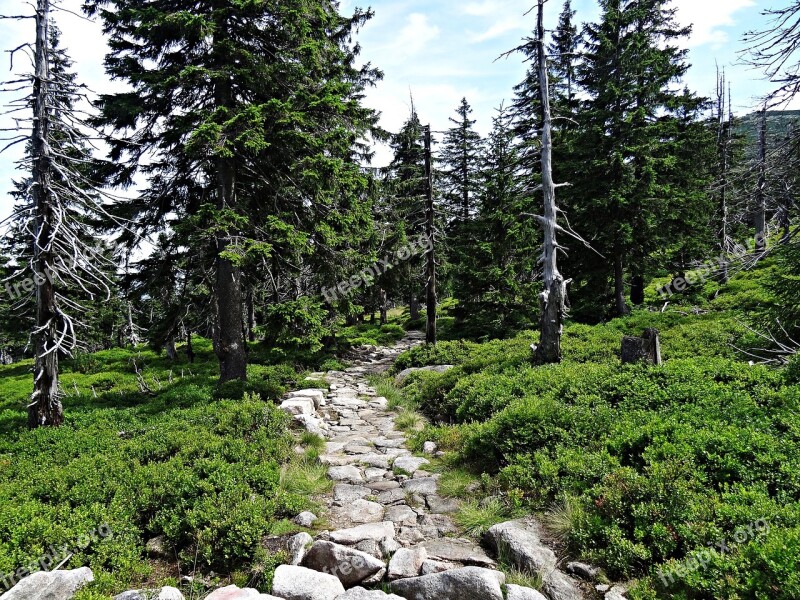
[88,0,380,381]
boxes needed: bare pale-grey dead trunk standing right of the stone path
[536,0,567,364]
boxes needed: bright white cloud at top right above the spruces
[673,0,756,48]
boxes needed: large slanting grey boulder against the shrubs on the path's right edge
[488,520,556,574]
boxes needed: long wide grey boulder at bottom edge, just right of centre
[391,567,506,600]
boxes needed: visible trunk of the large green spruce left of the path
[214,32,247,381]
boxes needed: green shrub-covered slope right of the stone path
[390,264,800,600]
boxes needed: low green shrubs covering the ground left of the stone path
[0,340,309,598]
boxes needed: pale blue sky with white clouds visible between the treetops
[0,0,787,216]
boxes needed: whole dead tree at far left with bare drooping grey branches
[2,0,110,428]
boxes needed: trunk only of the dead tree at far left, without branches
[28,0,64,429]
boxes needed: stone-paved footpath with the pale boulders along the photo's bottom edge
[3,332,625,600]
